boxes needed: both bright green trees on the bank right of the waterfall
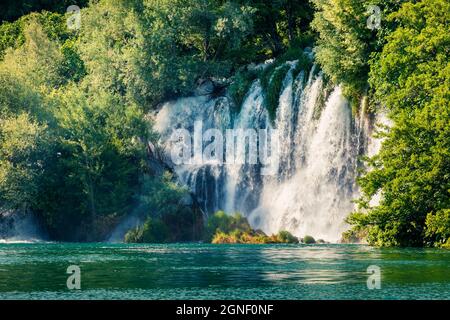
[312,0,450,246]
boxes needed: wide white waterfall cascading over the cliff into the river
[155,61,378,242]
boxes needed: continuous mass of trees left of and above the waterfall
[0,0,312,242]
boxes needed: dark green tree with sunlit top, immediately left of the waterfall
[47,88,148,230]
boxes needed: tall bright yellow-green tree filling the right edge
[349,0,450,246]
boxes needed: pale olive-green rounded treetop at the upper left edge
[0,14,86,94]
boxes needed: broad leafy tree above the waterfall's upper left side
[80,0,252,109]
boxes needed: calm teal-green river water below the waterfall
[0,242,450,299]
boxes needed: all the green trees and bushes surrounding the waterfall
[0,0,450,246]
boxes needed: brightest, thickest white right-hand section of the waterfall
[249,88,354,241]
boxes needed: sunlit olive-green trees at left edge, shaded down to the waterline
[0,7,152,240]
